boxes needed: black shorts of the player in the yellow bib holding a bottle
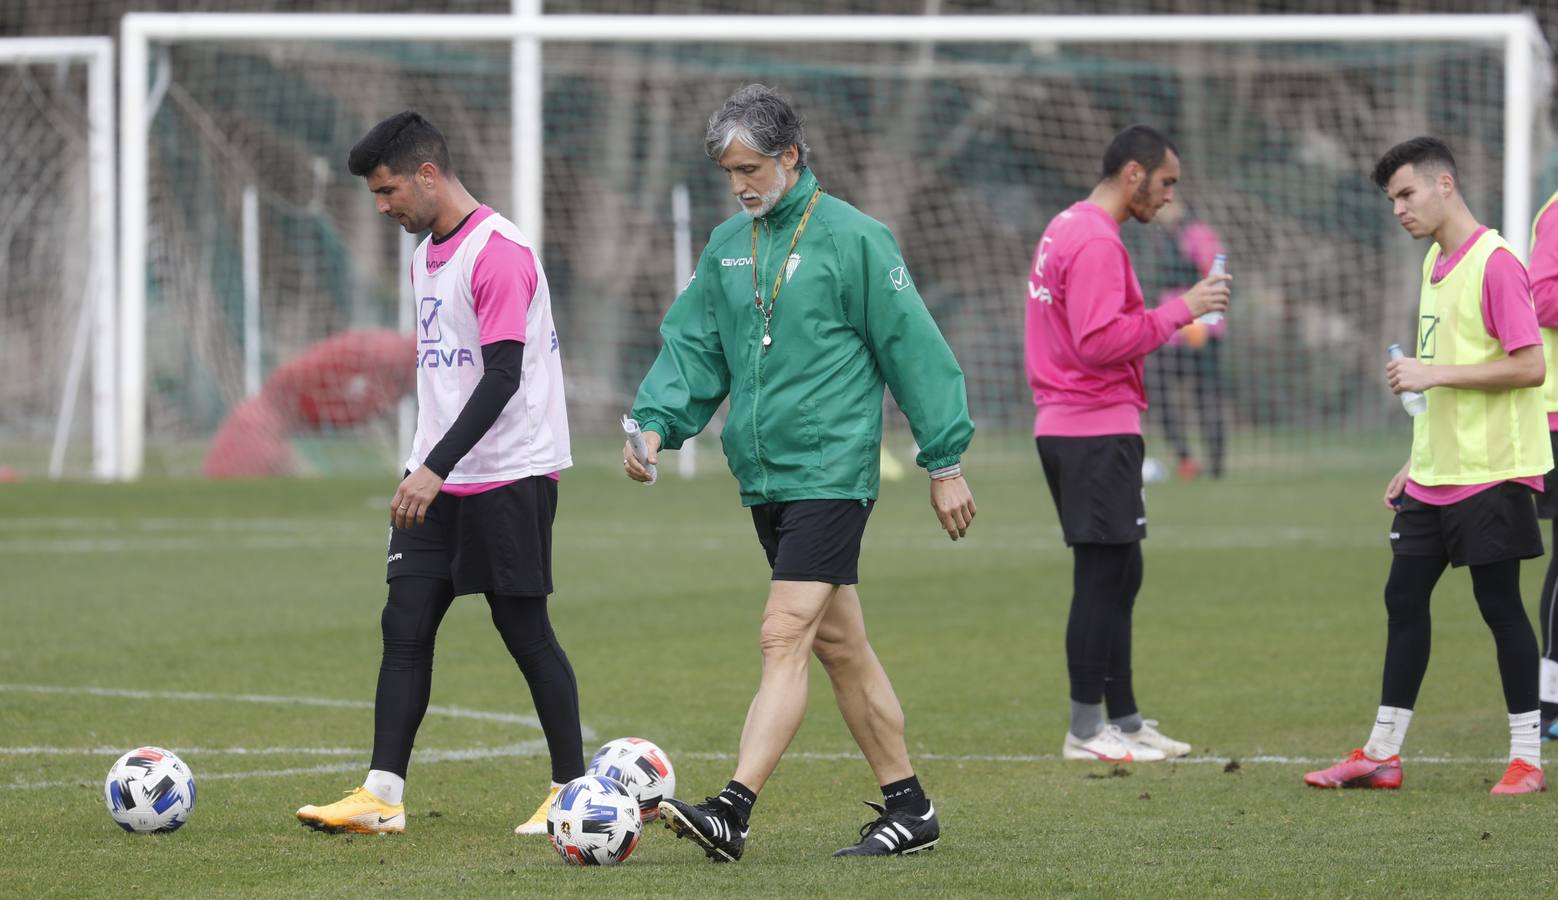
[1390,481,1542,567]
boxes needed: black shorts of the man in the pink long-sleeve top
[1035,434,1147,547]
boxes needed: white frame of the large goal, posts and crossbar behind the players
[118,10,1550,480]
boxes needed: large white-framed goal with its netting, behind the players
[115,16,1552,475]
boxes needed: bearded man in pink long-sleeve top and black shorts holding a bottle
[1027,125,1228,763]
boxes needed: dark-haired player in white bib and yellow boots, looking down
[298,111,584,835]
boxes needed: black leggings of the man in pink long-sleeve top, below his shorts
[1066,542,1142,719]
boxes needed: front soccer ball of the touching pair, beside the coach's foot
[547,775,643,866]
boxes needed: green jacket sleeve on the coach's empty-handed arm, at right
[846,226,974,472]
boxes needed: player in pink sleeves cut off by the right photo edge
[1530,193,1558,741]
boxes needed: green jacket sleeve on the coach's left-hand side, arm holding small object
[633,249,731,450]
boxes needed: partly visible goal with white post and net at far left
[0,37,120,480]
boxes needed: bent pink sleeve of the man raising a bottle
[1066,240,1192,367]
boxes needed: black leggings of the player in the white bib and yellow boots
[371,576,584,783]
